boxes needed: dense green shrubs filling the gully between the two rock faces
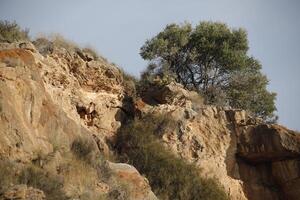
[116,116,227,200]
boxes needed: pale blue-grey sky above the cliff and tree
[0,0,300,131]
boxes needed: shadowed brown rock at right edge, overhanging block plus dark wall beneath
[237,124,300,199]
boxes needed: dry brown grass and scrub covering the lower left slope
[0,137,129,200]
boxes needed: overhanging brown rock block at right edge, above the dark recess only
[237,125,300,162]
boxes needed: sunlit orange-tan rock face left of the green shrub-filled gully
[0,42,157,200]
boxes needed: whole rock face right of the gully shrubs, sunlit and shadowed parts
[139,82,300,200]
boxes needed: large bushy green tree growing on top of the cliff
[140,22,276,120]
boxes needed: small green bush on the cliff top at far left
[0,20,29,43]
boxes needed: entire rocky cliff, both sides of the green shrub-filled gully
[0,39,300,200]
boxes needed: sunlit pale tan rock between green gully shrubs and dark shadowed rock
[148,104,247,200]
